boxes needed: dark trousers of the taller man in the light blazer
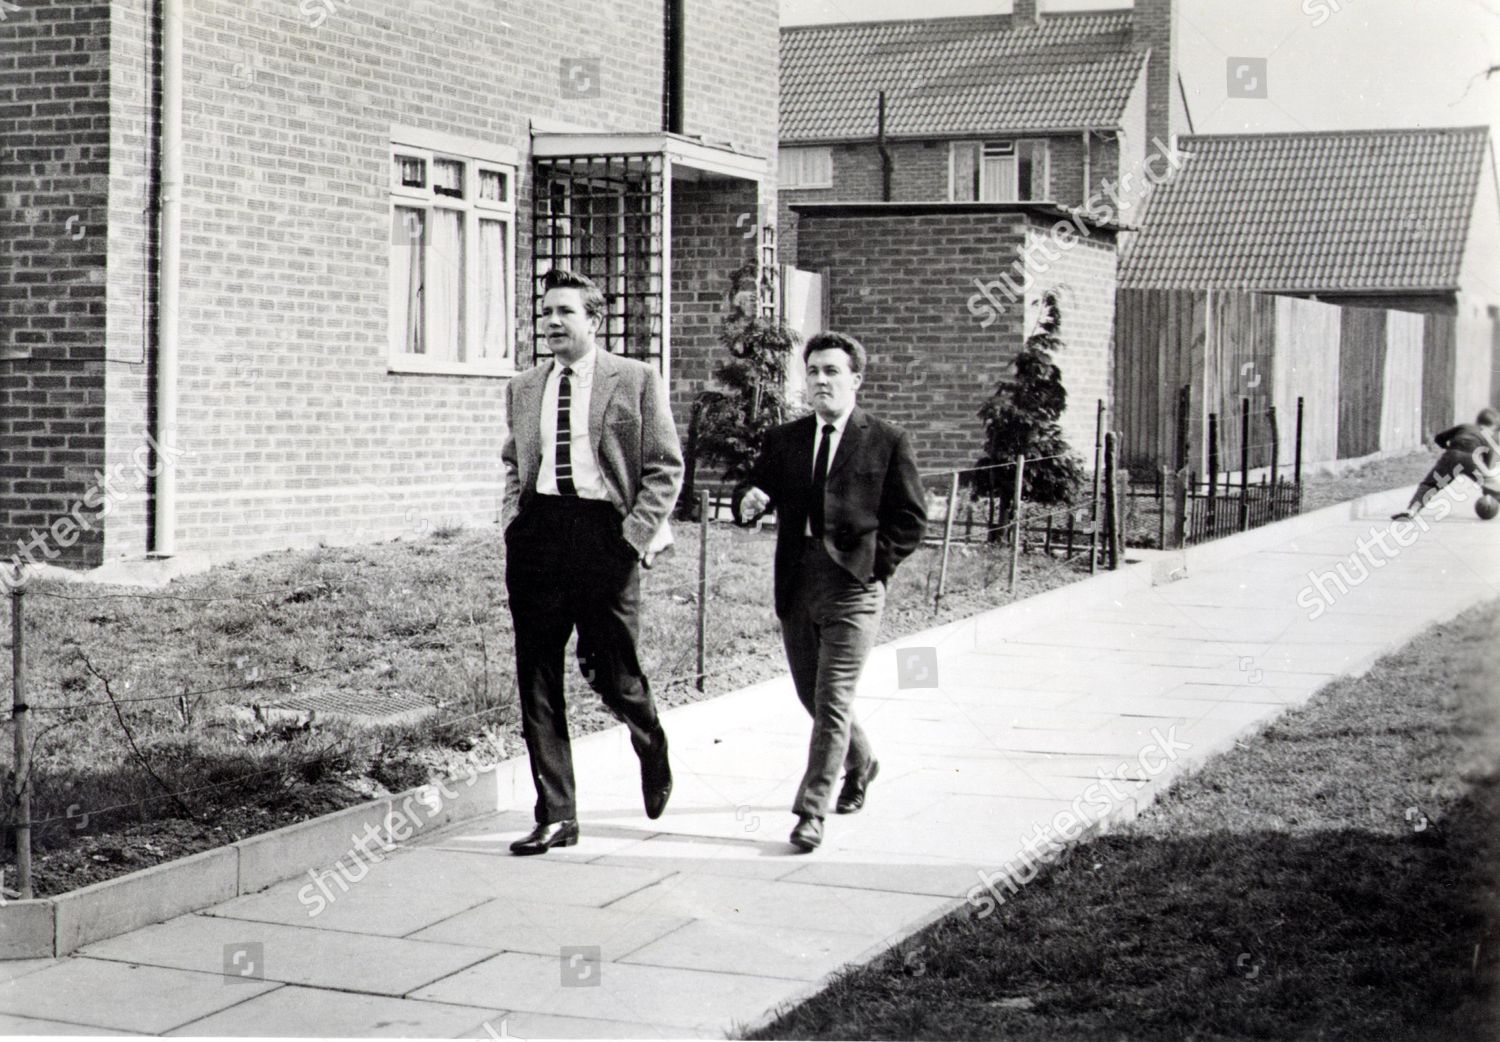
[506,495,660,823]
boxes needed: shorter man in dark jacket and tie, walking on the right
[738,333,927,852]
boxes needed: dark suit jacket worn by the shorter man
[735,406,927,616]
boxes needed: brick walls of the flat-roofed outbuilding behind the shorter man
[798,206,1115,471]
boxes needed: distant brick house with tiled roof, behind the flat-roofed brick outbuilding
[779,0,1191,259]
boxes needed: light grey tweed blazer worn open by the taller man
[500,348,683,555]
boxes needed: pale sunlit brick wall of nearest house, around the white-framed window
[11,0,777,558]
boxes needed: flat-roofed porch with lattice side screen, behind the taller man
[531,130,770,378]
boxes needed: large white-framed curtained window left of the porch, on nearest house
[390,141,516,375]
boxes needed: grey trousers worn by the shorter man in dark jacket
[782,540,885,817]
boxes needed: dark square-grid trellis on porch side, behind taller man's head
[531,153,668,369]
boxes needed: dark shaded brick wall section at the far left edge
[0,0,110,565]
